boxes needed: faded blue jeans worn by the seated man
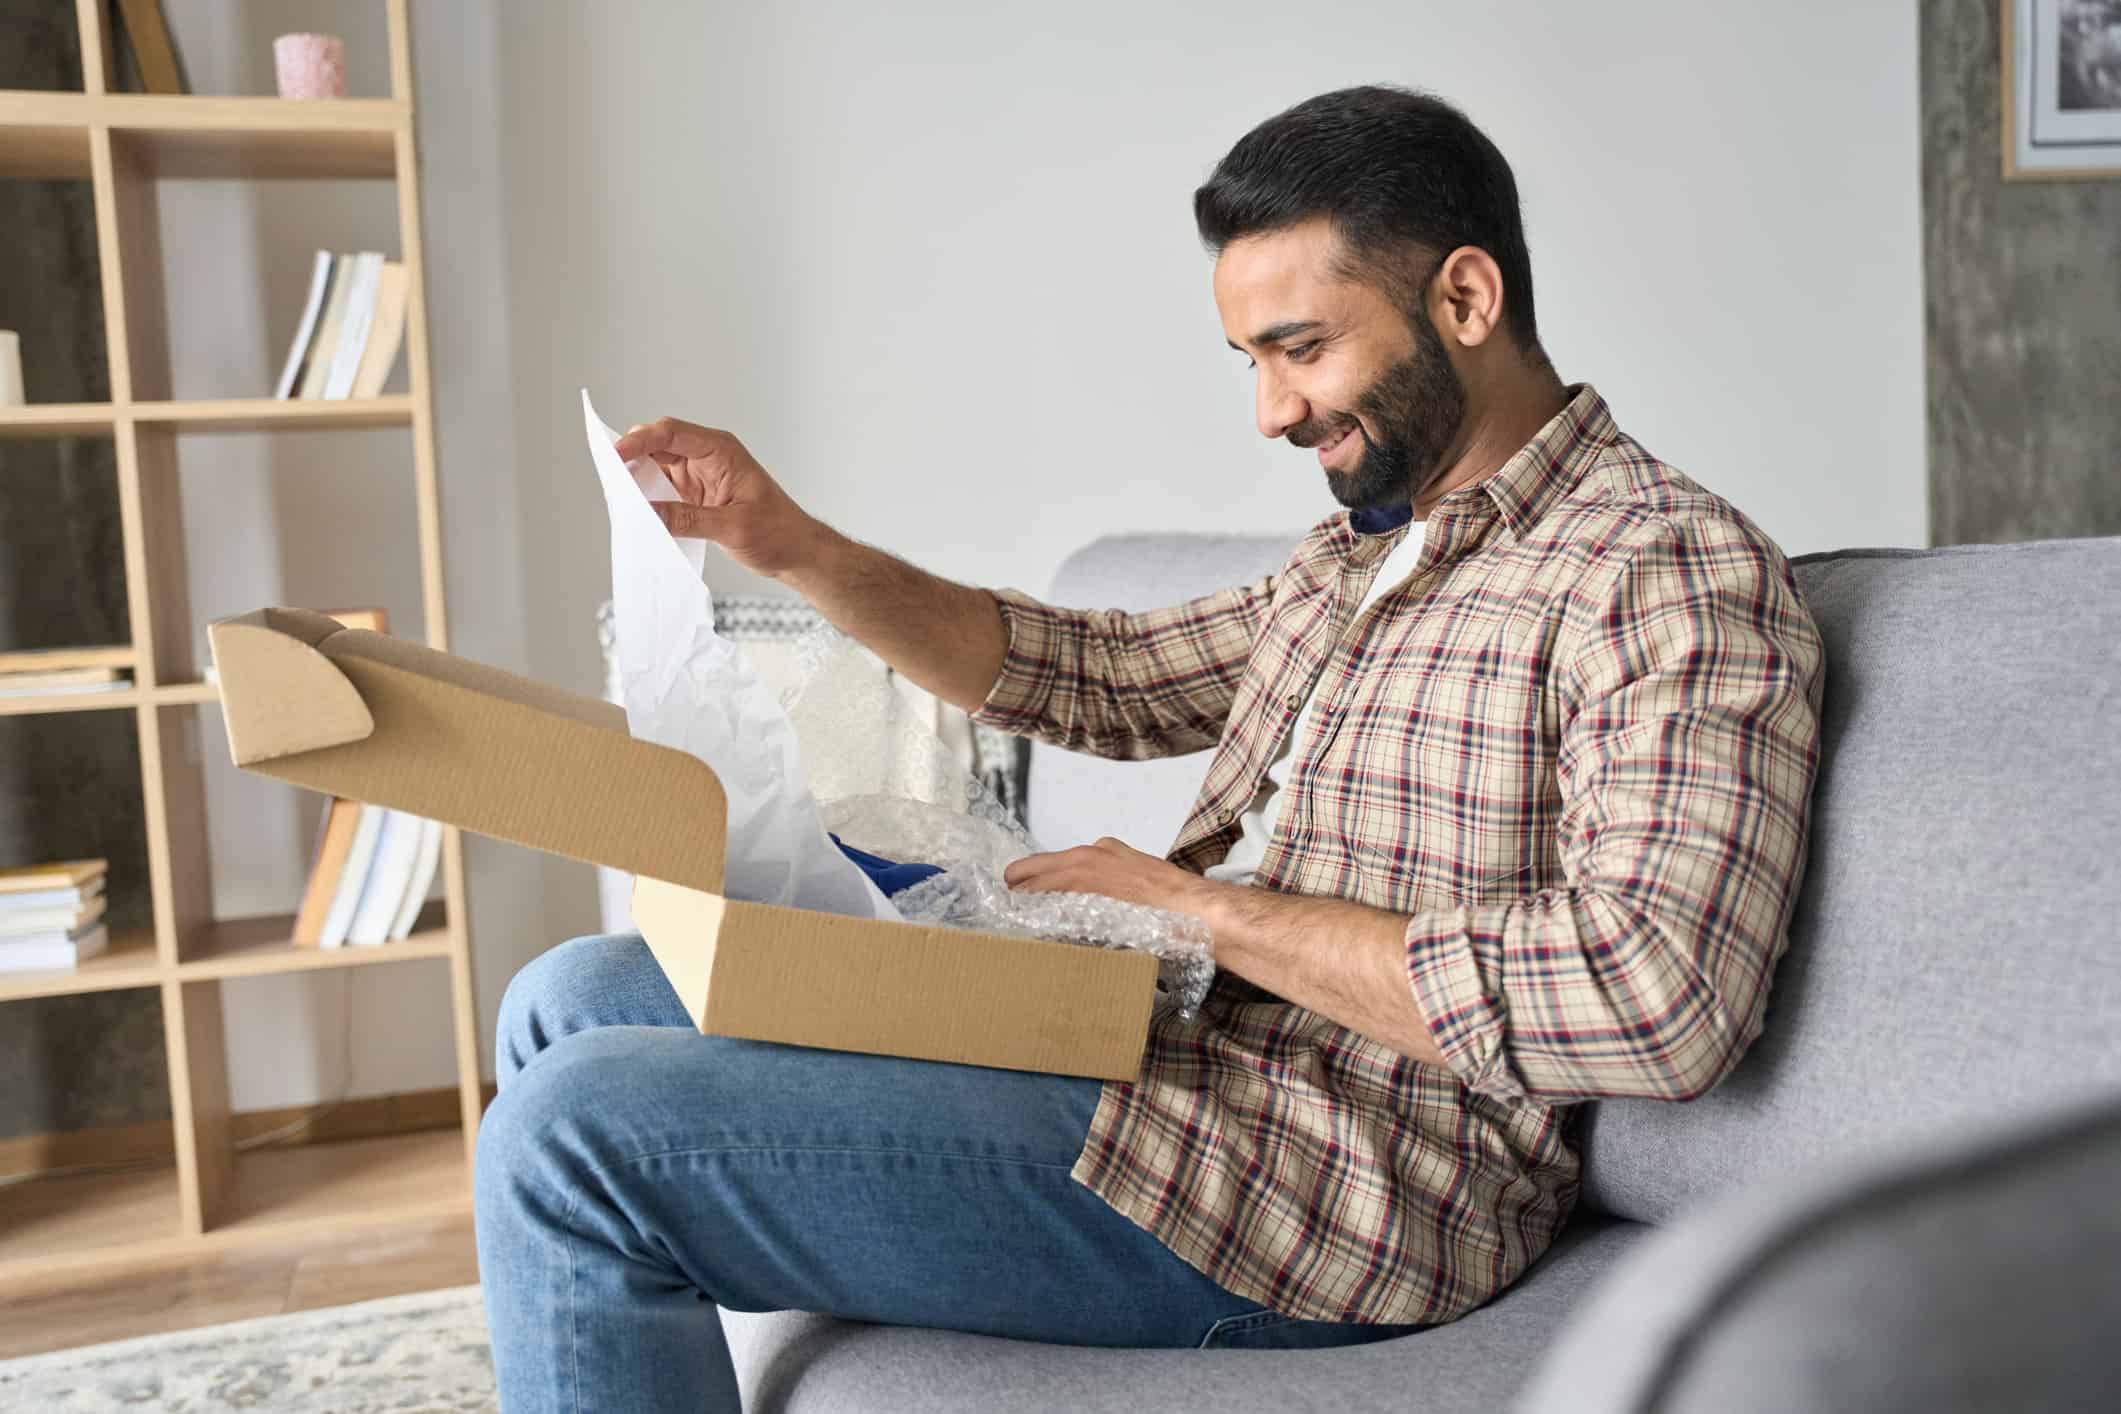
[477,935,1419,1414]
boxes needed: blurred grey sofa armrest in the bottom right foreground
[1521,1100,2121,1414]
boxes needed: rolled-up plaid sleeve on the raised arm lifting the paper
[971,575,1275,761]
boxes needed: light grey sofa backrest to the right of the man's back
[1584,536,2121,1221]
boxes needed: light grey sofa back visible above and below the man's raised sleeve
[1024,534,1300,854]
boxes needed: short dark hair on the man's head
[1194,85,1540,352]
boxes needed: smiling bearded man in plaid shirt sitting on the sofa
[477,87,1822,1410]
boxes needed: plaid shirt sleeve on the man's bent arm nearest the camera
[1406,517,1824,1100]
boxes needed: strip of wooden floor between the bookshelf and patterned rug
[0,1217,479,1359]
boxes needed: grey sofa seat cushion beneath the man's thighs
[721,1223,1646,1414]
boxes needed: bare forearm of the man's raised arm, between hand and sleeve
[778,524,1010,712]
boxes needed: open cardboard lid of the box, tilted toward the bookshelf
[208,608,730,892]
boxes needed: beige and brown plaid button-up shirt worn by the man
[978,386,1822,1323]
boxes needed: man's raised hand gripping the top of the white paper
[615,418,827,577]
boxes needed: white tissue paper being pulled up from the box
[581,388,899,920]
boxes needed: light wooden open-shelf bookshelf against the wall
[0,0,481,1276]
